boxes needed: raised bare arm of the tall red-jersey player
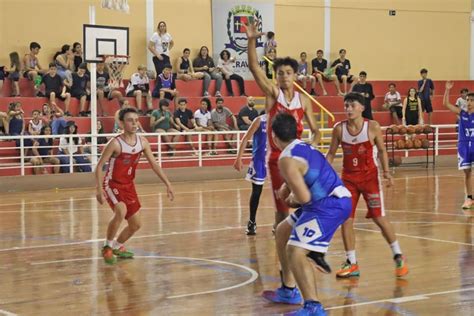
[245,19,278,98]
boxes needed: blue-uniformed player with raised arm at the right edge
[443,81,474,210]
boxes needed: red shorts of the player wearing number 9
[342,171,385,218]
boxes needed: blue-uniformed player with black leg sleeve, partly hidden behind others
[234,114,267,235]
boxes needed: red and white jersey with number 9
[339,120,378,178]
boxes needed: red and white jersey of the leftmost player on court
[104,135,143,187]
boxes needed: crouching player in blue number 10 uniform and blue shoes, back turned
[263,113,352,315]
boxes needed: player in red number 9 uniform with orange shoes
[326,93,408,278]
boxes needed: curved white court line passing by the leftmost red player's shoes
[30,256,259,299]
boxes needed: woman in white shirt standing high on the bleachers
[148,21,174,76]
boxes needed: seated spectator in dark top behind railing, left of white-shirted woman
[30,125,60,174]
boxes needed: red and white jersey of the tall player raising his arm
[267,89,304,160]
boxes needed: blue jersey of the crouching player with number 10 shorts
[280,139,351,210]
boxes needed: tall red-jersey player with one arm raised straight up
[246,20,320,227]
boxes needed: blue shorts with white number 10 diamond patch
[287,196,352,253]
